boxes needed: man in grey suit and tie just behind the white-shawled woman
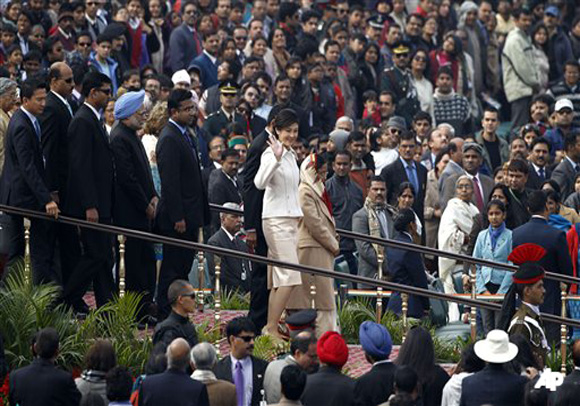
[441,142,494,213]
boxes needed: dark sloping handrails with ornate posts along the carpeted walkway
[0,205,580,374]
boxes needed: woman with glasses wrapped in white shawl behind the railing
[438,175,479,321]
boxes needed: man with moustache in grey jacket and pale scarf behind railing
[352,176,394,289]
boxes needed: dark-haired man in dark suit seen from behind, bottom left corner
[9,327,81,406]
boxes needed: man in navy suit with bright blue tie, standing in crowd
[381,132,427,221]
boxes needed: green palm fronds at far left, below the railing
[0,263,152,375]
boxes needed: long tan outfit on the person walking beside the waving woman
[287,183,339,310]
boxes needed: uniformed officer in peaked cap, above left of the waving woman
[203,80,246,139]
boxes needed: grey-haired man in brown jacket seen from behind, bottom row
[191,342,237,406]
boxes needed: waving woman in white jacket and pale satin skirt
[254,109,302,337]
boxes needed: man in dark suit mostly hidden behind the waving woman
[243,106,280,331]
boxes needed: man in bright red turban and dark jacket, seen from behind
[302,331,354,406]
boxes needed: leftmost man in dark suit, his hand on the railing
[1,79,60,284]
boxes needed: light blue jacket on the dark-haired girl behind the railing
[473,228,512,294]
